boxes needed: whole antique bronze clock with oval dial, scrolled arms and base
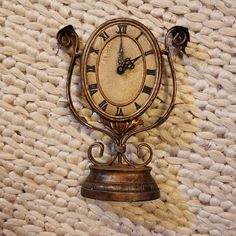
[57,18,189,201]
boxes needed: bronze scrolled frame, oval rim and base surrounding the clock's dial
[57,18,190,201]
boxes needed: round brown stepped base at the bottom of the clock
[81,165,160,202]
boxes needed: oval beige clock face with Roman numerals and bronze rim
[81,18,161,121]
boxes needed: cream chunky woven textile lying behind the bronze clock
[0,0,236,236]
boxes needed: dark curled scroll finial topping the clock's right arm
[165,26,190,53]
